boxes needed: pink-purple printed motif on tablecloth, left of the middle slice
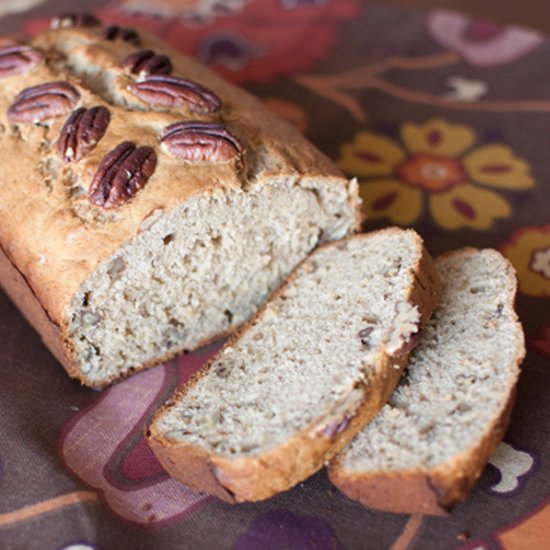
[59,347,222,526]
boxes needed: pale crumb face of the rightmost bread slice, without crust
[337,250,523,475]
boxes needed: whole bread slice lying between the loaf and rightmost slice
[148,229,439,502]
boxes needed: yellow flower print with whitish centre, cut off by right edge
[500,225,550,298]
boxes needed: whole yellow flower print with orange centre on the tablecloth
[339,119,534,230]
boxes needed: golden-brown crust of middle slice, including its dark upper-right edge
[147,228,440,502]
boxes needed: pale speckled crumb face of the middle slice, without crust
[152,230,422,458]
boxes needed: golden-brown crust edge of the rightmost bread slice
[329,247,525,515]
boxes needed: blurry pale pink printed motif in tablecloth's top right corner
[426,10,544,66]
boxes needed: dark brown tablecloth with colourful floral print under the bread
[0,0,550,550]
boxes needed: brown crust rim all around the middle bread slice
[148,228,439,502]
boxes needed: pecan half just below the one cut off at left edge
[8,82,80,122]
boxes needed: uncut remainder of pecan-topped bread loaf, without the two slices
[0,15,359,386]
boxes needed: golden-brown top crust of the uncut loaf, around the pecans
[0,22,359,332]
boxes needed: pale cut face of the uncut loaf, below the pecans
[68,181,358,385]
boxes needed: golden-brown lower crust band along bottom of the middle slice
[151,356,414,503]
